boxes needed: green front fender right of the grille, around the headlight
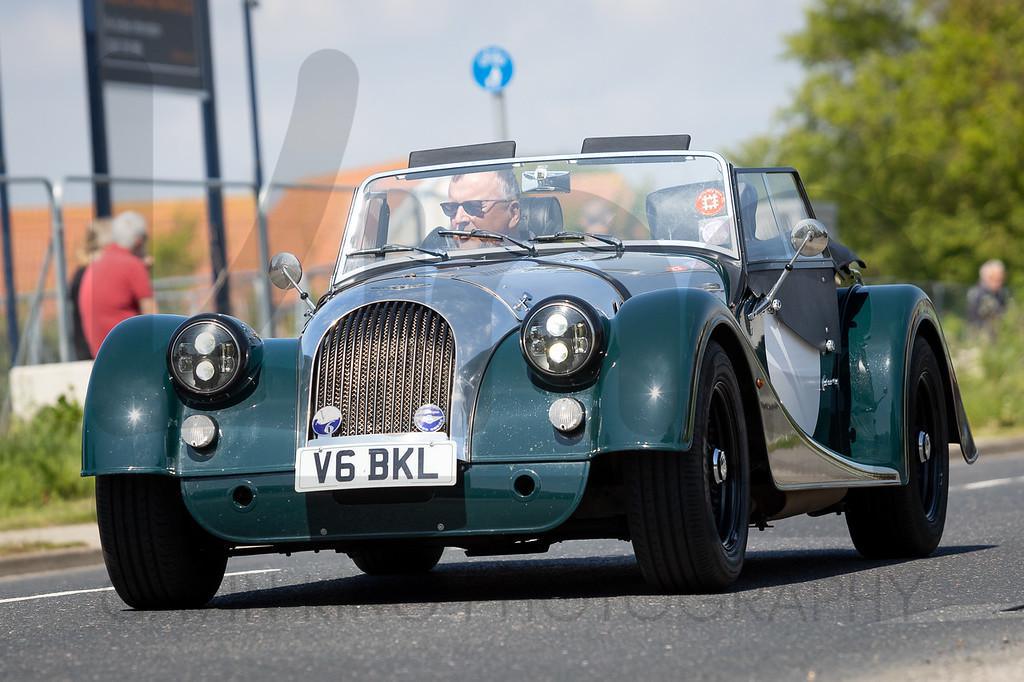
[472,289,734,462]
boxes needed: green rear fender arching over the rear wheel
[843,285,978,483]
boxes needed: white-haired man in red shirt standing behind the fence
[78,211,157,357]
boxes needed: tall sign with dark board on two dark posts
[82,0,229,312]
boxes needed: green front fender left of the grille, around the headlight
[82,315,299,477]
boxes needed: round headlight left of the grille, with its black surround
[167,314,262,399]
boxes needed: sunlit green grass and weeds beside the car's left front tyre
[0,397,93,518]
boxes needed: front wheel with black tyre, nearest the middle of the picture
[628,342,750,592]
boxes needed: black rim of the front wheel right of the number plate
[705,382,745,550]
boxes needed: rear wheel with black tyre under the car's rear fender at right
[846,337,949,559]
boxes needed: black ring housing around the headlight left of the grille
[167,312,263,404]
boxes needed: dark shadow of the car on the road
[211,545,995,609]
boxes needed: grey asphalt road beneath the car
[0,454,1024,680]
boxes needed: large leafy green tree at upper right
[738,0,1024,283]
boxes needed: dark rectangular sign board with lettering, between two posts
[95,0,210,90]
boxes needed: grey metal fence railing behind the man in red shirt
[0,175,354,367]
